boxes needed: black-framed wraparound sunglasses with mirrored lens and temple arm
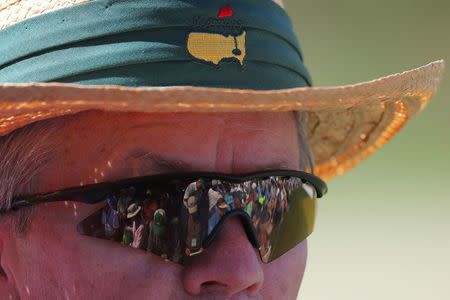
[12,170,327,265]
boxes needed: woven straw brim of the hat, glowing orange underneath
[0,61,444,179]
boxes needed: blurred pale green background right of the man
[286,0,450,300]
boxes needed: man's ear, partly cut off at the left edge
[0,232,20,300]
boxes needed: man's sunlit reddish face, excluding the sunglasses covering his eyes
[0,111,307,299]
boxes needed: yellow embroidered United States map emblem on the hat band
[187,31,246,66]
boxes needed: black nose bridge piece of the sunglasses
[202,209,260,249]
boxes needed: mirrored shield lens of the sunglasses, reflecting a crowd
[78,176,316,264]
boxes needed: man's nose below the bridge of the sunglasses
[183,217,264,297]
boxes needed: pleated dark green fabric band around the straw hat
[0,0,311,89]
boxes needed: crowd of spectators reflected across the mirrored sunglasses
[90,177,302,262]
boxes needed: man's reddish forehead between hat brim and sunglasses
[36,111,299,190]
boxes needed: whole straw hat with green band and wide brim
[0,0,444,179]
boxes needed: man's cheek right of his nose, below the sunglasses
[262,240,308,299]
